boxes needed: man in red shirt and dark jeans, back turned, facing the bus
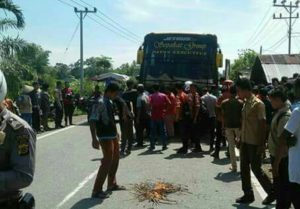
[149,85,171,151]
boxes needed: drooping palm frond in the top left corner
[0,0,25,31]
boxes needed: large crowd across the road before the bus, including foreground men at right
[89,75,300,209]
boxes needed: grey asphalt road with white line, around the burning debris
[26,122,274,209]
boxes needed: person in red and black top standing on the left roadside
[62,82,75,126]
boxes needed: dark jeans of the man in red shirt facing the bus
[150,120,167,148]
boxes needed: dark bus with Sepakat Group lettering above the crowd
[137,33,223,86]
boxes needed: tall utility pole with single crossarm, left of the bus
[74,7,97,95]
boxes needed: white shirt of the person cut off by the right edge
[285,108,300,184]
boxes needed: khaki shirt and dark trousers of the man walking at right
[240,95,272,195]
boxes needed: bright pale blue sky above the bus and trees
[4,0,300,67]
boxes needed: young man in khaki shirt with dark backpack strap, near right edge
[263,87,291,209]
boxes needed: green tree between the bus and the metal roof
[229,49,258,80]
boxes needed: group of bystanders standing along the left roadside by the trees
[4,81,75,133]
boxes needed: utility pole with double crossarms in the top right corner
[273,0,300,55]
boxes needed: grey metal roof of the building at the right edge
[254,54,300,83]
